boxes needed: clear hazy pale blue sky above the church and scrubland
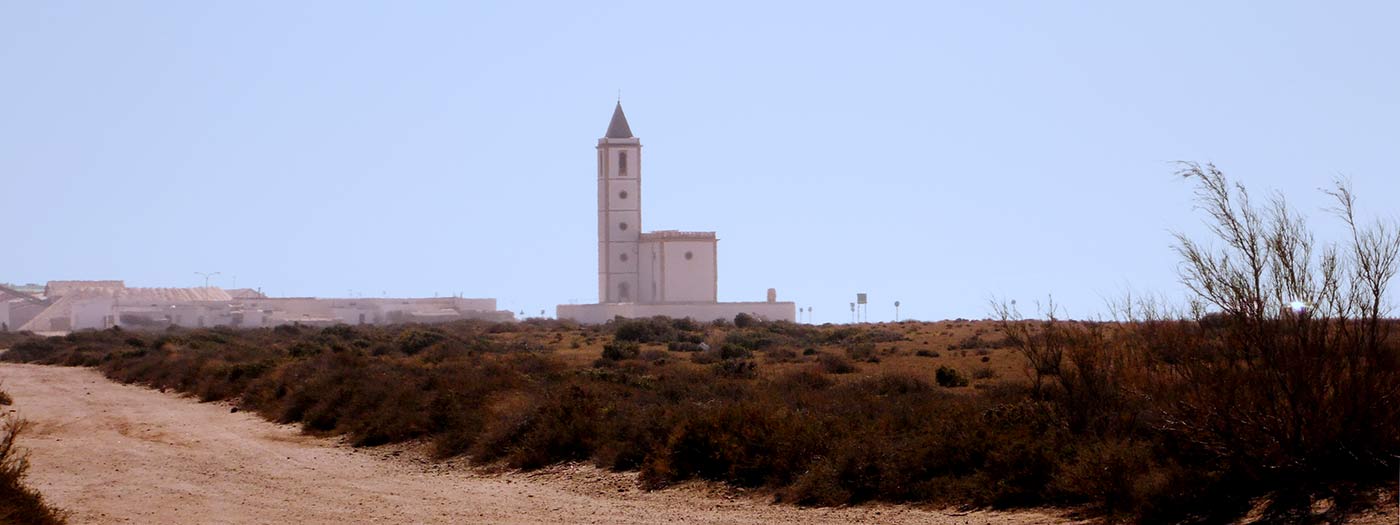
[0,0,1400,321]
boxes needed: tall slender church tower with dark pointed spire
[598,102,641,302]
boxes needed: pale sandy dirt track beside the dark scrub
[0,364,1065,525]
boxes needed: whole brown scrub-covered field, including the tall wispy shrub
[3,164,1400,522]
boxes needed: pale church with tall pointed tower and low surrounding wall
[556,102,797,323]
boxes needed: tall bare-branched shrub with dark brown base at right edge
[1130,164,1400,509]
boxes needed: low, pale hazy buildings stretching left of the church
[0,281,515,333]
